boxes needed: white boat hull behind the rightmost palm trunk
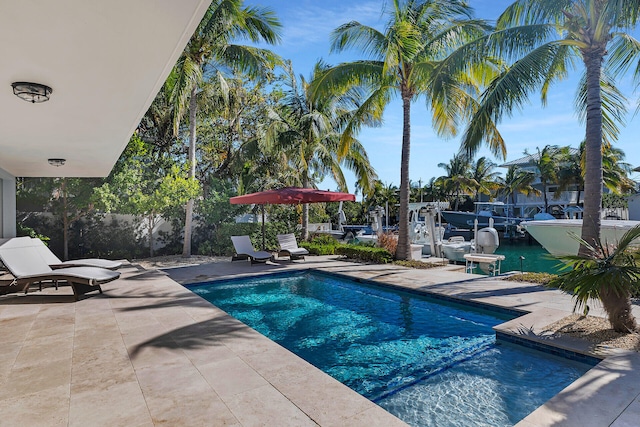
[520,219,640,256]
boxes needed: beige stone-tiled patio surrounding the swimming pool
[0,257,640,427]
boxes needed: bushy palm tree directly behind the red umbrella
[267,62,377,240]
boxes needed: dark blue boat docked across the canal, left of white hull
[442,202,530,236]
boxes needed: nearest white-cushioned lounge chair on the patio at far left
[0,237,120,300]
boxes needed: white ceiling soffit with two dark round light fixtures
[0,0,210,177]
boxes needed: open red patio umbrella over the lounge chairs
[229,187,356,249]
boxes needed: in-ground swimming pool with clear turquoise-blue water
[190,273,592,427]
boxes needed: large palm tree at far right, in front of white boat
[463,0,640,254]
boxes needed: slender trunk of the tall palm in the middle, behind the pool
[396,89,411,260]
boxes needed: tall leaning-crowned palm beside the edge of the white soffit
[166,0,280,256]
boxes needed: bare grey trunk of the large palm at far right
[579,48,609,258]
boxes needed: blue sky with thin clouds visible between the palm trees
[250,0,640,196]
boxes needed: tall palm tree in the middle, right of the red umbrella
[314,0,490,259]
